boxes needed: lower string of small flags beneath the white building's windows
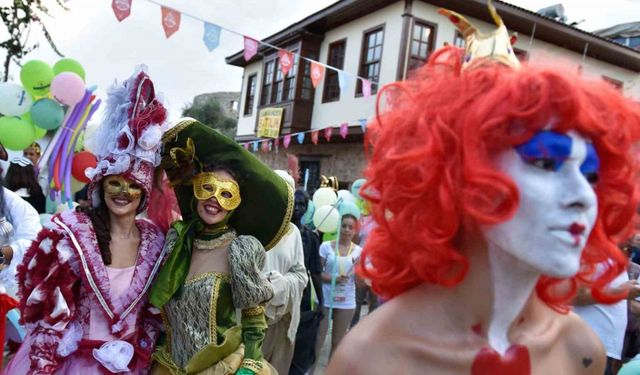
[240,118,367,152]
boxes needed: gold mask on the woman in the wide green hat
[193,172,242,211]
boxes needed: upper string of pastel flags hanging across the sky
[111,0,378,98]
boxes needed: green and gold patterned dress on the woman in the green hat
[152,224,273,375]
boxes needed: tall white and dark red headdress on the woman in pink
[86,66,167,212]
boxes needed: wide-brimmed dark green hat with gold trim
[161,118,294,250]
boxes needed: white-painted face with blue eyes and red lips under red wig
[483,131,598,278]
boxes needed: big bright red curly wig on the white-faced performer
[359,47,640,311]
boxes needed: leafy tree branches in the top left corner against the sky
[0,0,69,81]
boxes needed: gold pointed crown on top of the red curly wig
[438,0,520,69]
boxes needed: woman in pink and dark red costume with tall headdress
[5,66,166,375]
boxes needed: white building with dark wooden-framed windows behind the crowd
[227,0,640,191]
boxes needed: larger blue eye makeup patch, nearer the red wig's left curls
[515,130,572,171]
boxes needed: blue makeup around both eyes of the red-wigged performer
[515,130,600,183]
